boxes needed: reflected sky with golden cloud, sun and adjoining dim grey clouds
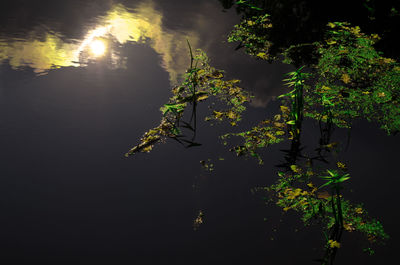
[0,0,292,107]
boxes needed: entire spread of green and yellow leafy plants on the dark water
[126,5,400,264]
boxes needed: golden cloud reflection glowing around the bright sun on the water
[0,1,199,83]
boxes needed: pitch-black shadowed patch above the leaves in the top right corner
[219,0,400,60]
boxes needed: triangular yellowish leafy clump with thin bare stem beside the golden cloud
[126,45,250,156]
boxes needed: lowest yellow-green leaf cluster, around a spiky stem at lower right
[266,164,389,243]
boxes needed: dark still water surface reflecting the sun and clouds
[0,0,400,265]
